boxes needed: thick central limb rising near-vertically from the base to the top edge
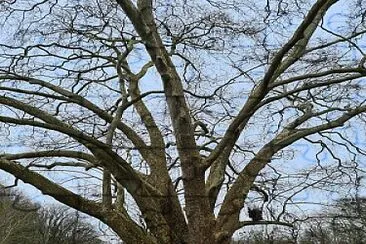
[117,0,213,242]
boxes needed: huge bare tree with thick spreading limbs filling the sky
[0,0,366,244]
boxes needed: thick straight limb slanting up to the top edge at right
[204,0,344,210]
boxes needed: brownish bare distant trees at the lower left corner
[0,188,105,244]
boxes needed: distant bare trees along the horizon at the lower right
[231,197,366,244]
